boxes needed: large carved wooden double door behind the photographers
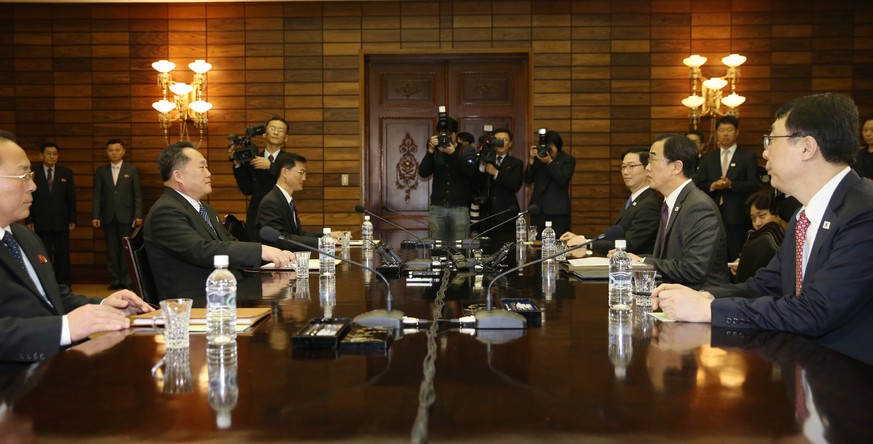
[363,53,533,231]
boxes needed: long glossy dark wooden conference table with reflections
[0,246,873,443]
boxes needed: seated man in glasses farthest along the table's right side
[561,146,663,256]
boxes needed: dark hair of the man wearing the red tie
[776,93,859,165]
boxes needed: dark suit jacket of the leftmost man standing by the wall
[26,165,76,231]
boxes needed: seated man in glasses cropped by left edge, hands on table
[0,137,152,362]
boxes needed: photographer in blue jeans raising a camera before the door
[418,107,477,243]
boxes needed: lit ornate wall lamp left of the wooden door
[152,60,212,146]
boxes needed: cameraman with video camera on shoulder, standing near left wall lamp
[227,116,288,241]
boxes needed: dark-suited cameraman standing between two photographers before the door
[479,128,524,251]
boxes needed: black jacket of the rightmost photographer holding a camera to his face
[524,151,576,215]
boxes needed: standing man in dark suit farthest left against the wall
[25,142,76,287]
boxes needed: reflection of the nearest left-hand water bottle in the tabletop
[206,341,239,429]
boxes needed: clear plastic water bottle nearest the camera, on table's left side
[206,255,236,345]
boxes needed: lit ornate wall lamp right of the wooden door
[682,54,746,134]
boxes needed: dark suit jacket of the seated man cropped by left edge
[0,224,100,362]
